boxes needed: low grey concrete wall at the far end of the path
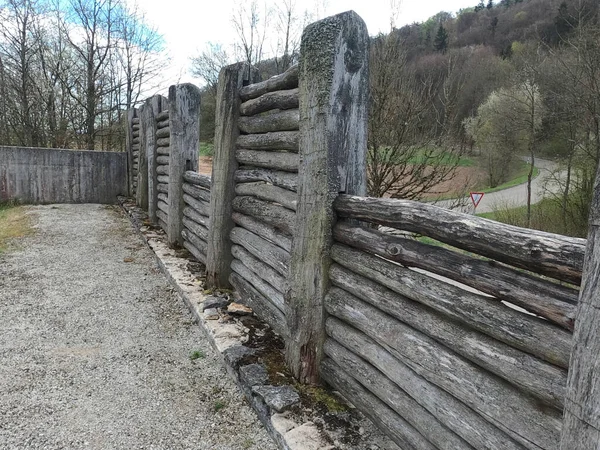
[0,146,128,204]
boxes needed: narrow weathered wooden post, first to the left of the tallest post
[206,63,258,288]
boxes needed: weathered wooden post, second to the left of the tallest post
[167,83,200,245]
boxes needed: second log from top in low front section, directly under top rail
[333,222,578,330]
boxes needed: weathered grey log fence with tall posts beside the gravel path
[127,12,600,450]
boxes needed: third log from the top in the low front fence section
[331,244,571,370]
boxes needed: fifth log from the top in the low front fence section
[325,286,561,450]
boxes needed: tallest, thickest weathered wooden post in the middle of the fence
[286,11,369,383]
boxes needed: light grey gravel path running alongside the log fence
[0,205,276,450]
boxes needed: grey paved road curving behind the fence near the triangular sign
[436,158,559,213]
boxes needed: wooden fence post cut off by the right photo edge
[560,161,600,450]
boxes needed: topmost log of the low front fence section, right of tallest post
[334,195,586,284]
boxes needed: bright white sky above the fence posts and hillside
[128,0,478,89]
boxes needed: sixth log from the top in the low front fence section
[326,316,524,450]
